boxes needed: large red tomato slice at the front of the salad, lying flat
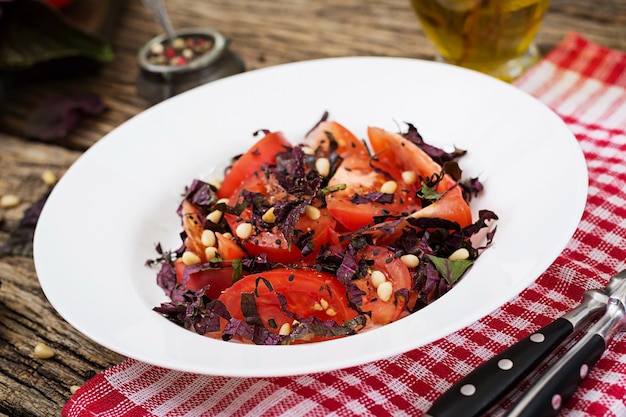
[219,268,358,340]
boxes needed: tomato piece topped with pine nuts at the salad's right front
[354,246,411,325]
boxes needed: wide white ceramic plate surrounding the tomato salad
[34,57,587,376]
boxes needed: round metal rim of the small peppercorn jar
[137,27,228,75]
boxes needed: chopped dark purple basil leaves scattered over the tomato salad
[147,113,498,345]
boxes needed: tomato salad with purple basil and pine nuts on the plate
[148,114,497,345]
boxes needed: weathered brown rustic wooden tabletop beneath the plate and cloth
[0,0,626,416]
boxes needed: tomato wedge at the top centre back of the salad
[304,121,368,158]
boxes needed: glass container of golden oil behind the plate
[411,0,550,81]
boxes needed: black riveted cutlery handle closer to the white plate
[425,317,574,417]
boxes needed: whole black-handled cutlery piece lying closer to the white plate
[424,270,626,417]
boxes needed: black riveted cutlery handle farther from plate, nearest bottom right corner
[506,334,606,417]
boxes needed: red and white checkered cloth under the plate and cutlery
[63,33,626,417]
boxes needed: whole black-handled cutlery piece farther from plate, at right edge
[505,272,626,417]
